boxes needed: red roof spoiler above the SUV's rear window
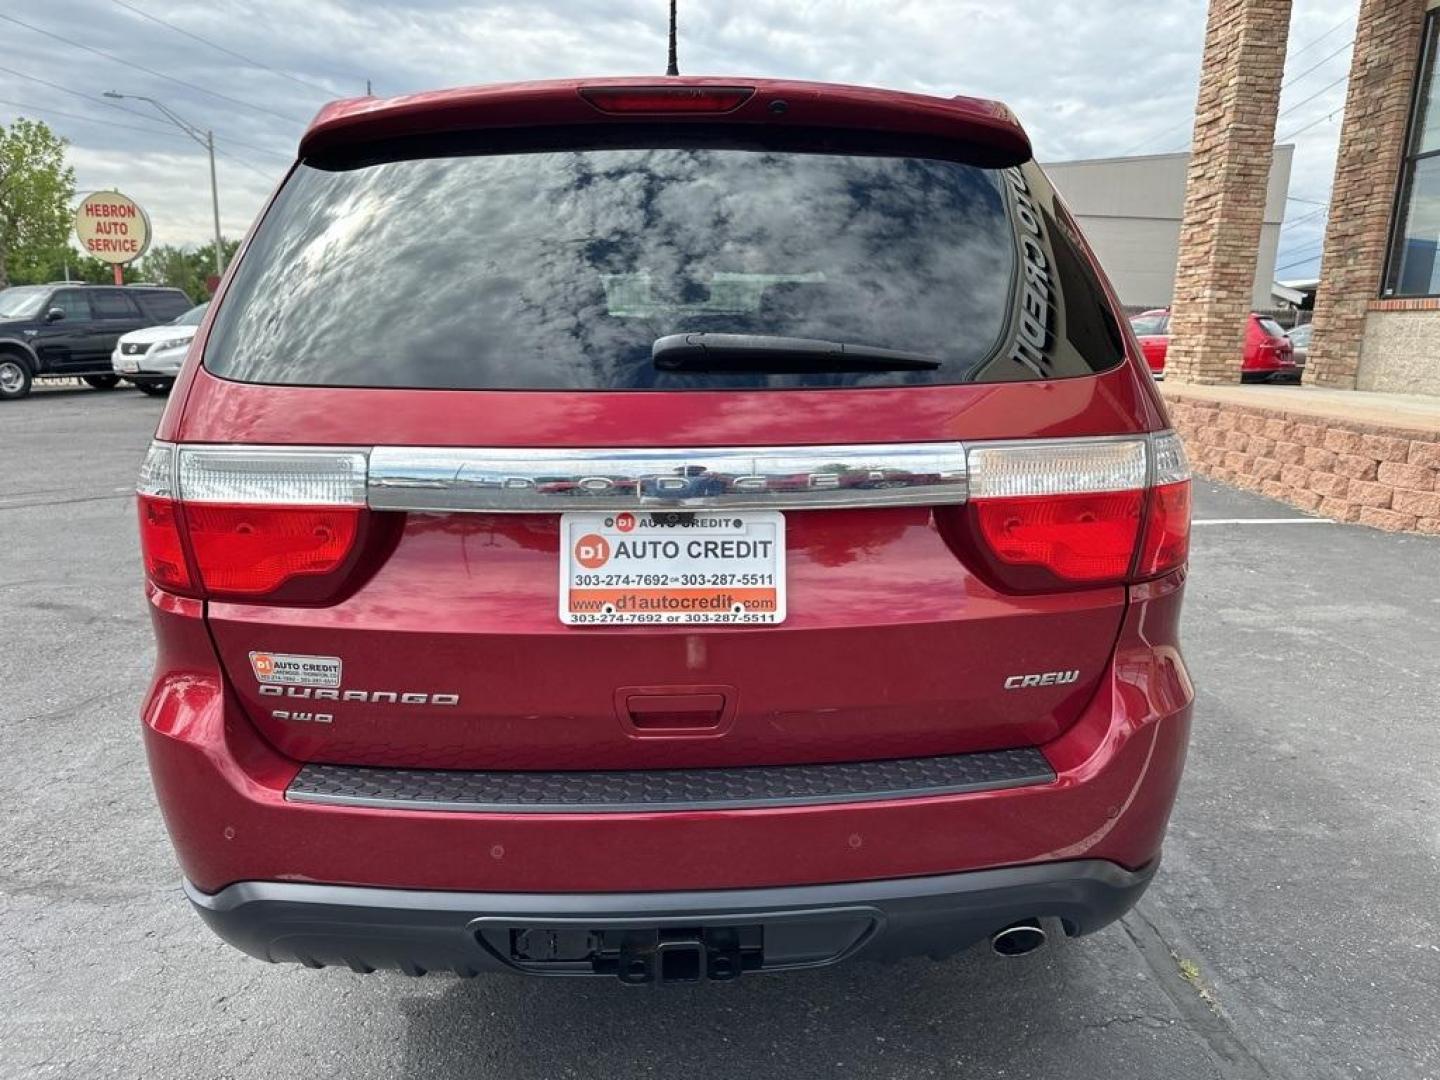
[300,76,1031,167]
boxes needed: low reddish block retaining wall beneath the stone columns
[1168,399,1440,536]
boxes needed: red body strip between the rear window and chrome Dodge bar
[180,361,1165,448]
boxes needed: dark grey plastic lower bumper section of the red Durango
[186,860,1155,982]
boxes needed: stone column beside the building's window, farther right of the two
[1305,0,1426,390]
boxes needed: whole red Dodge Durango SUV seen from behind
[138,78,1194,984]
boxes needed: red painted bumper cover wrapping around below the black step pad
[144,575,1194,891]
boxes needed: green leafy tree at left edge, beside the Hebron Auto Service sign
[0,117,75,288]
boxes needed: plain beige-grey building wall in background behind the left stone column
[1044,146,1290,308]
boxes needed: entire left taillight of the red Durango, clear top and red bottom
[140,442,373,602]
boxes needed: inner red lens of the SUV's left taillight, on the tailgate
[184,504,360,598]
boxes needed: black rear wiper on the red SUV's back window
[651,334,942,374]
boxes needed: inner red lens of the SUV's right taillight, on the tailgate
[975,491,1143,582]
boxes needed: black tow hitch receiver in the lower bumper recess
[510,926,765,986]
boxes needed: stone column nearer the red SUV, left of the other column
[1165,0,1290,383]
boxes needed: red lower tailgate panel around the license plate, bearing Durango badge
[210,507,1125,769]
